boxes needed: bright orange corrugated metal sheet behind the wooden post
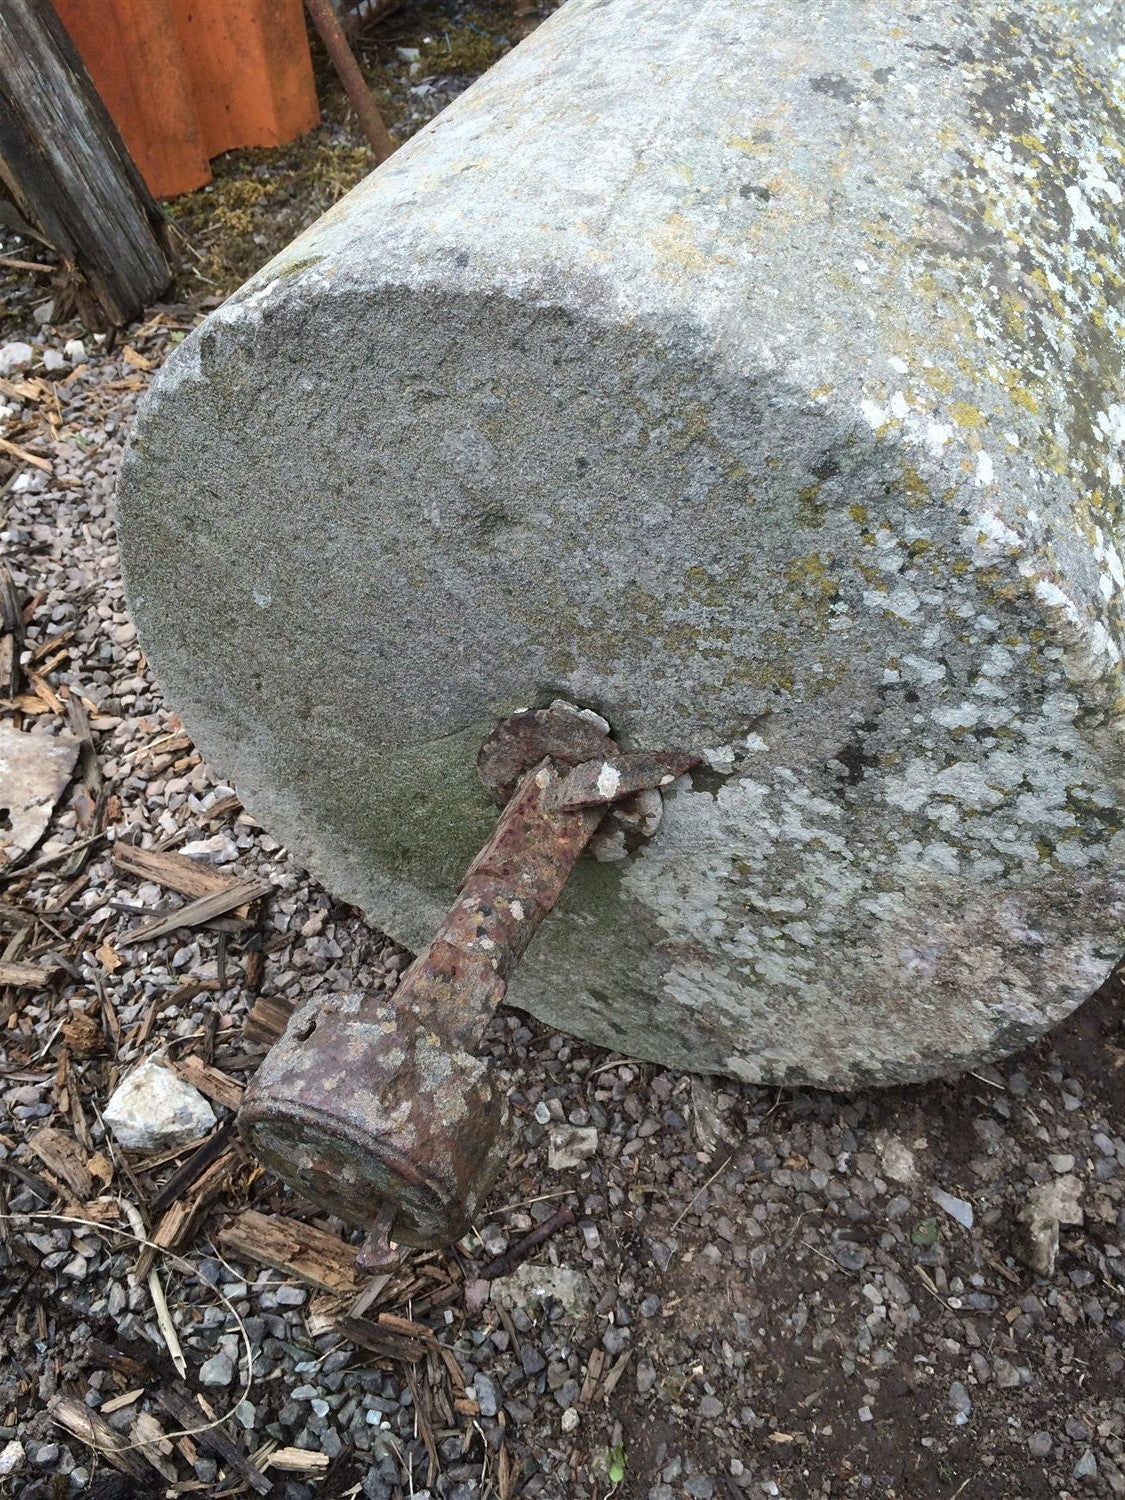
[54,0,320,198]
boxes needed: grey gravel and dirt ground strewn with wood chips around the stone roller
[0,5,1125,1500]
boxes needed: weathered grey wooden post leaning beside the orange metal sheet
[0,0,173,324]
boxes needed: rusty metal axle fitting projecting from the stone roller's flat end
[239,705,699,1268]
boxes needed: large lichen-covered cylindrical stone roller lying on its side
[122,0,1125,1086]
